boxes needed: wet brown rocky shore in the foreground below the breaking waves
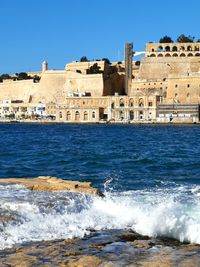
[0,230,200,267]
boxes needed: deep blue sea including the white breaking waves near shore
[0,123,200,249]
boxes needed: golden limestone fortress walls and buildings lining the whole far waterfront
[0,43,200,123]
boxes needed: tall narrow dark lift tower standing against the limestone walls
[125,43,133,95]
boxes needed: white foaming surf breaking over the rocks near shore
[0,186,200,249]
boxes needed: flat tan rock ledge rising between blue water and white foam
[0,176,103,196]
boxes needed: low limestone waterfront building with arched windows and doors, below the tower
[56,95,159,123]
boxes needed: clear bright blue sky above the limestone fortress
[0,0,200,73]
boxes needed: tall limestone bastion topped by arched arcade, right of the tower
[132,43,200,122]
